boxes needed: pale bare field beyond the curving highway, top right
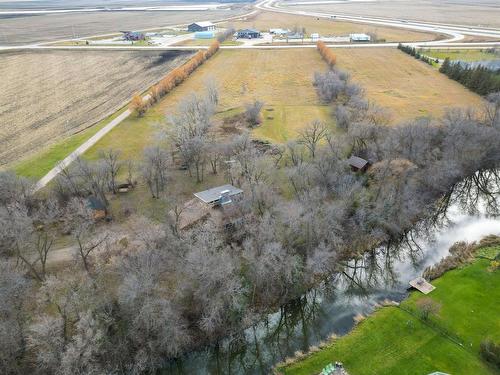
[282,0,500,27]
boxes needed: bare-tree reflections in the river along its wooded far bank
[170,170,500,374]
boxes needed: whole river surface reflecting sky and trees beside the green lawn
[162,171,500,374]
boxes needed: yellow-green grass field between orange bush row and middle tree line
[86,49,333,160]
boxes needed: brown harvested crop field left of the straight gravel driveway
[0,51,191,165]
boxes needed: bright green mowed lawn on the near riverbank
[277,239,500,375]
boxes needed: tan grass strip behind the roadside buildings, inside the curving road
[225,12,439,42]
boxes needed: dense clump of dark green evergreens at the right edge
[439,57,500,95]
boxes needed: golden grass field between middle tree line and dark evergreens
[334,48,484,121]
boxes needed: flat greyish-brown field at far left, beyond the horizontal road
[0,6,248,45]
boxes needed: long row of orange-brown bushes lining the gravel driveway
[131,40,220,116]
